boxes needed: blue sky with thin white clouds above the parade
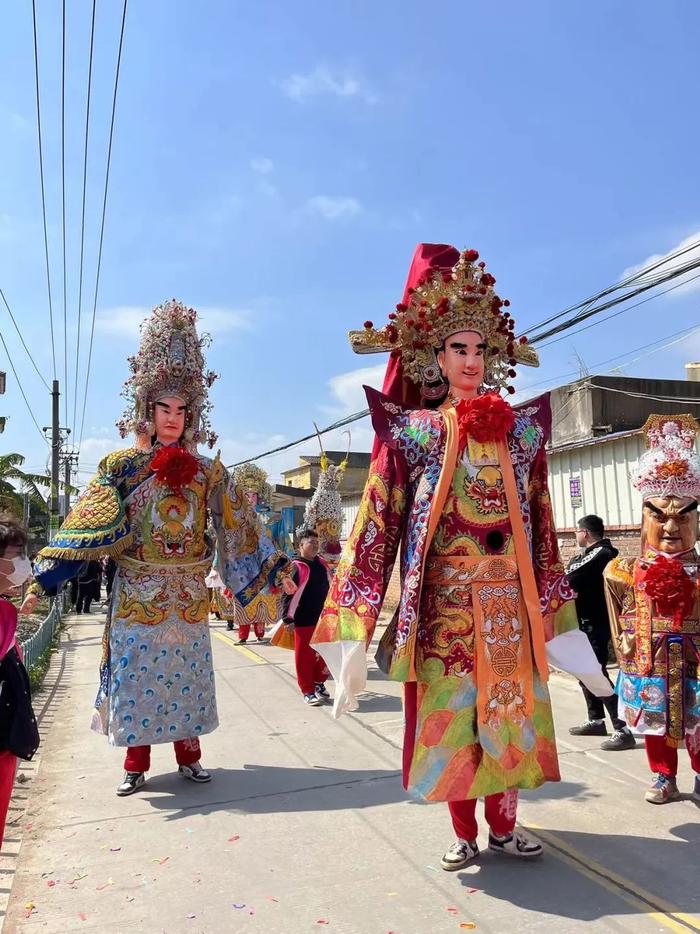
[0,0,700,490]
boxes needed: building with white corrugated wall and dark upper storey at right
[547,374,700,560]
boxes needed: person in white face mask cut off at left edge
[0,515,39,846]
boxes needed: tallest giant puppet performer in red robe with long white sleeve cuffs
[314,244,611,870]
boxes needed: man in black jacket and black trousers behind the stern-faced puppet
[567,515,636,752]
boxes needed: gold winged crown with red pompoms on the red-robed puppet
[350,250,539,392]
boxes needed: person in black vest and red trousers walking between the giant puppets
[282,529,330,707]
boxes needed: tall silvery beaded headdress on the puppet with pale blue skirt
[117,299,217,447]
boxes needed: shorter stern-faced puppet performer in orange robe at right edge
[604,415,700,804]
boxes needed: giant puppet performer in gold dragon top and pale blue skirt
[25,301,287,795]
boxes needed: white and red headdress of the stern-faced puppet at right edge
[630,415,700,499]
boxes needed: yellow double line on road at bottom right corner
[518,821,700,934]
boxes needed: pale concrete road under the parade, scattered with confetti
[0,617,700,934]
